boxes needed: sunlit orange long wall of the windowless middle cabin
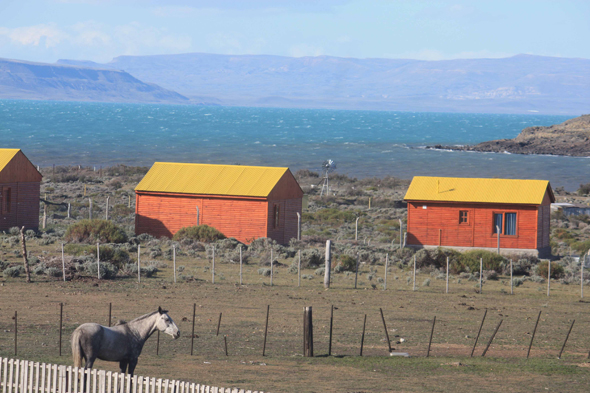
[135,192,267,243]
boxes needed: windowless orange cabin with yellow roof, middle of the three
[135,162,303,244]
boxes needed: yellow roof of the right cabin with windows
[404,176,555,205]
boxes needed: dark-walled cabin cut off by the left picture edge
[0,149,43,231]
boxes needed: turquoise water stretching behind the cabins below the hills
[0,100,590,190]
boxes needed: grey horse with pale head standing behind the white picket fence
[72,307,180,375]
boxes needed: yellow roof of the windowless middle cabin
[135,162,289,197]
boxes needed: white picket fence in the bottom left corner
[0,357,263,393]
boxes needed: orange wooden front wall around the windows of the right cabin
[407,201,537,249]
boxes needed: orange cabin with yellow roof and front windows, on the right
[404,176,555,256]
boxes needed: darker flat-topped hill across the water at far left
[0,59,190,104]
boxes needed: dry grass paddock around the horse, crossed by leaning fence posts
[0,256,590,392]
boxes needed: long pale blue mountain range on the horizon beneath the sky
[58,53,590,115]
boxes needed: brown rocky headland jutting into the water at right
[434,115,590,157]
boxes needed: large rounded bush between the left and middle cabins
[65,220,127,243]
